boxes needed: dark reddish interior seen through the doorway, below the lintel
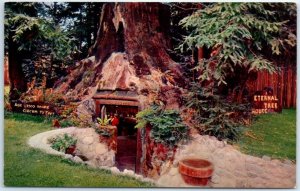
[100,105,138,171]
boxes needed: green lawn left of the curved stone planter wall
[4,113,153,187]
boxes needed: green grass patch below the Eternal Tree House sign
[237,109,296,160]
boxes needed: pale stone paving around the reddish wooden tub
[157,134,296,188]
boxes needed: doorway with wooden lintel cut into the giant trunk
[93,91,140,172]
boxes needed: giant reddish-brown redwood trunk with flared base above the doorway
[56,3,184,115]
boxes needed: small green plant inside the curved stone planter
[51,133,77,152]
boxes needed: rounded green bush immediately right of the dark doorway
[135,105,189,146]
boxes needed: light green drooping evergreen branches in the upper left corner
[5,3,75,60]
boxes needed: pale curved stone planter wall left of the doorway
[28,127,156,185]
